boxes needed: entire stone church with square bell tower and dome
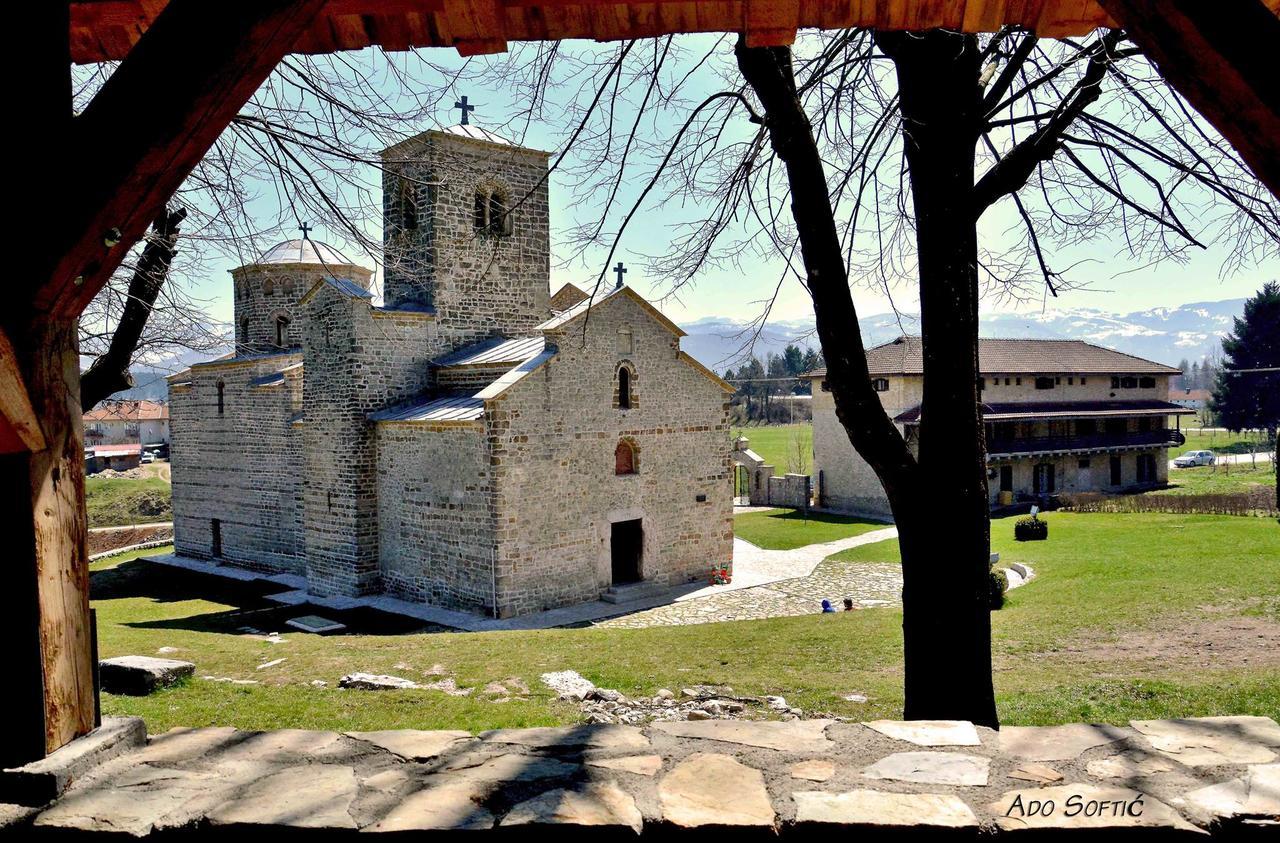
[169,125,733,617]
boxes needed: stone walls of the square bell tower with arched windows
[383,132,550,348]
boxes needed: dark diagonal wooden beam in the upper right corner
[1098,0,1280,196]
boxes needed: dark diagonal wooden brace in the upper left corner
[31,0,325,323]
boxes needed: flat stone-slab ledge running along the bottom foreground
[12,716,1280,839]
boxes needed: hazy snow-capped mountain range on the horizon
[681,298,1244,372]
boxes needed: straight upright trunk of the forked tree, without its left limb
[876,29,997,727]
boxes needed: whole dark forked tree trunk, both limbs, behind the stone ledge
[737,35,997,727]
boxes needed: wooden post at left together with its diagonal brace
[0,0,325,766]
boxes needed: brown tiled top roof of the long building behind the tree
[806,336,1180,377]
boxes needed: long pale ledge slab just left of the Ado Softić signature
[792,791,978,830]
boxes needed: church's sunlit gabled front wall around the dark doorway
[488,295,733,617]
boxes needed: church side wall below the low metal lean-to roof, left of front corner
[376,422,494,611]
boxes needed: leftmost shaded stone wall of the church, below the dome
[170,353,305,573]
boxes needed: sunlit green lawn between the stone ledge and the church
[93,513,1280,730]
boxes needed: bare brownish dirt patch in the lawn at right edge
[1029,614,1280,668]
